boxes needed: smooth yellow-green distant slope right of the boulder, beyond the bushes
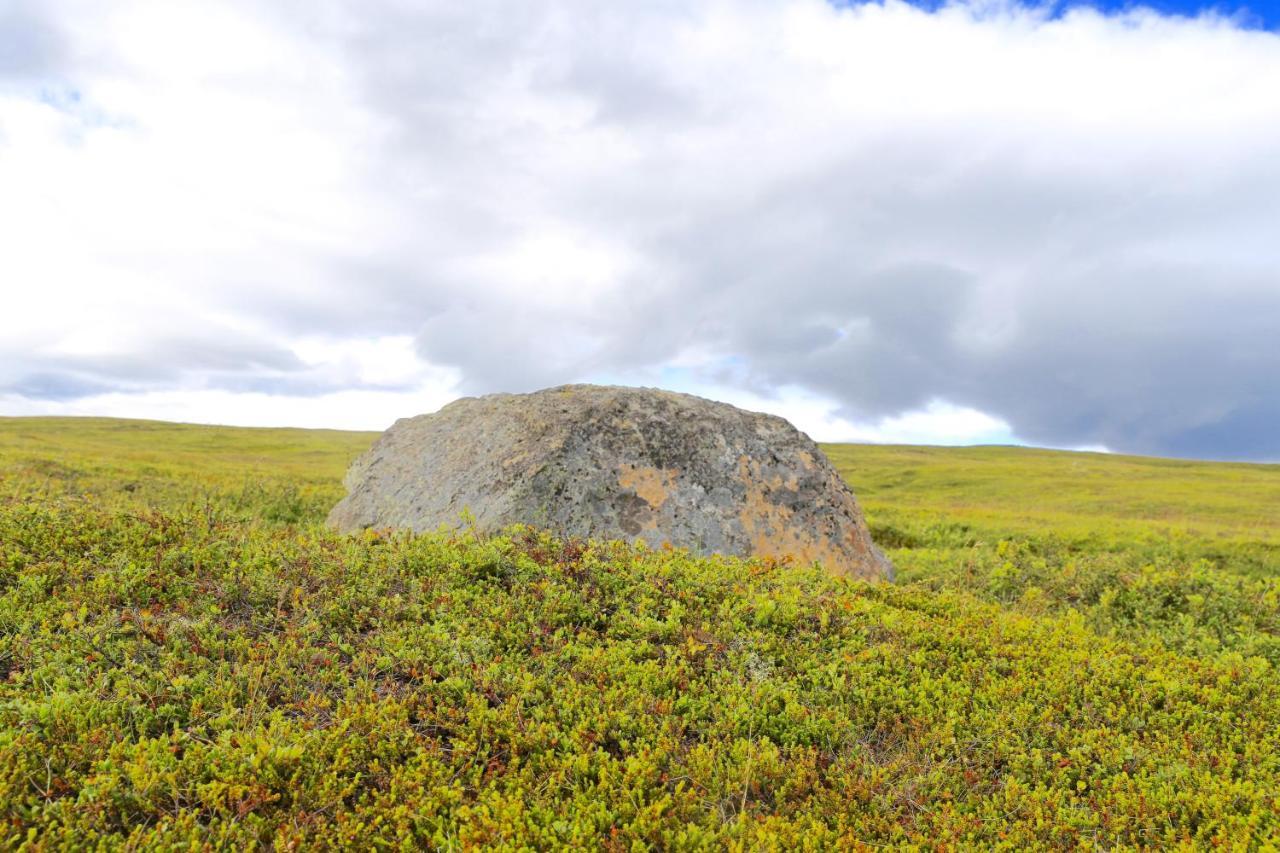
[826,444,1280,544]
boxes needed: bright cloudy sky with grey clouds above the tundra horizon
[0,0,1280,461]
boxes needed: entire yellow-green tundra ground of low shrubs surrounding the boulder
[0,419,1280,849]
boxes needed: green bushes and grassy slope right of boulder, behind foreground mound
[826,444,1280,666]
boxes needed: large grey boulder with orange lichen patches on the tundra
[329,386,892,578]
